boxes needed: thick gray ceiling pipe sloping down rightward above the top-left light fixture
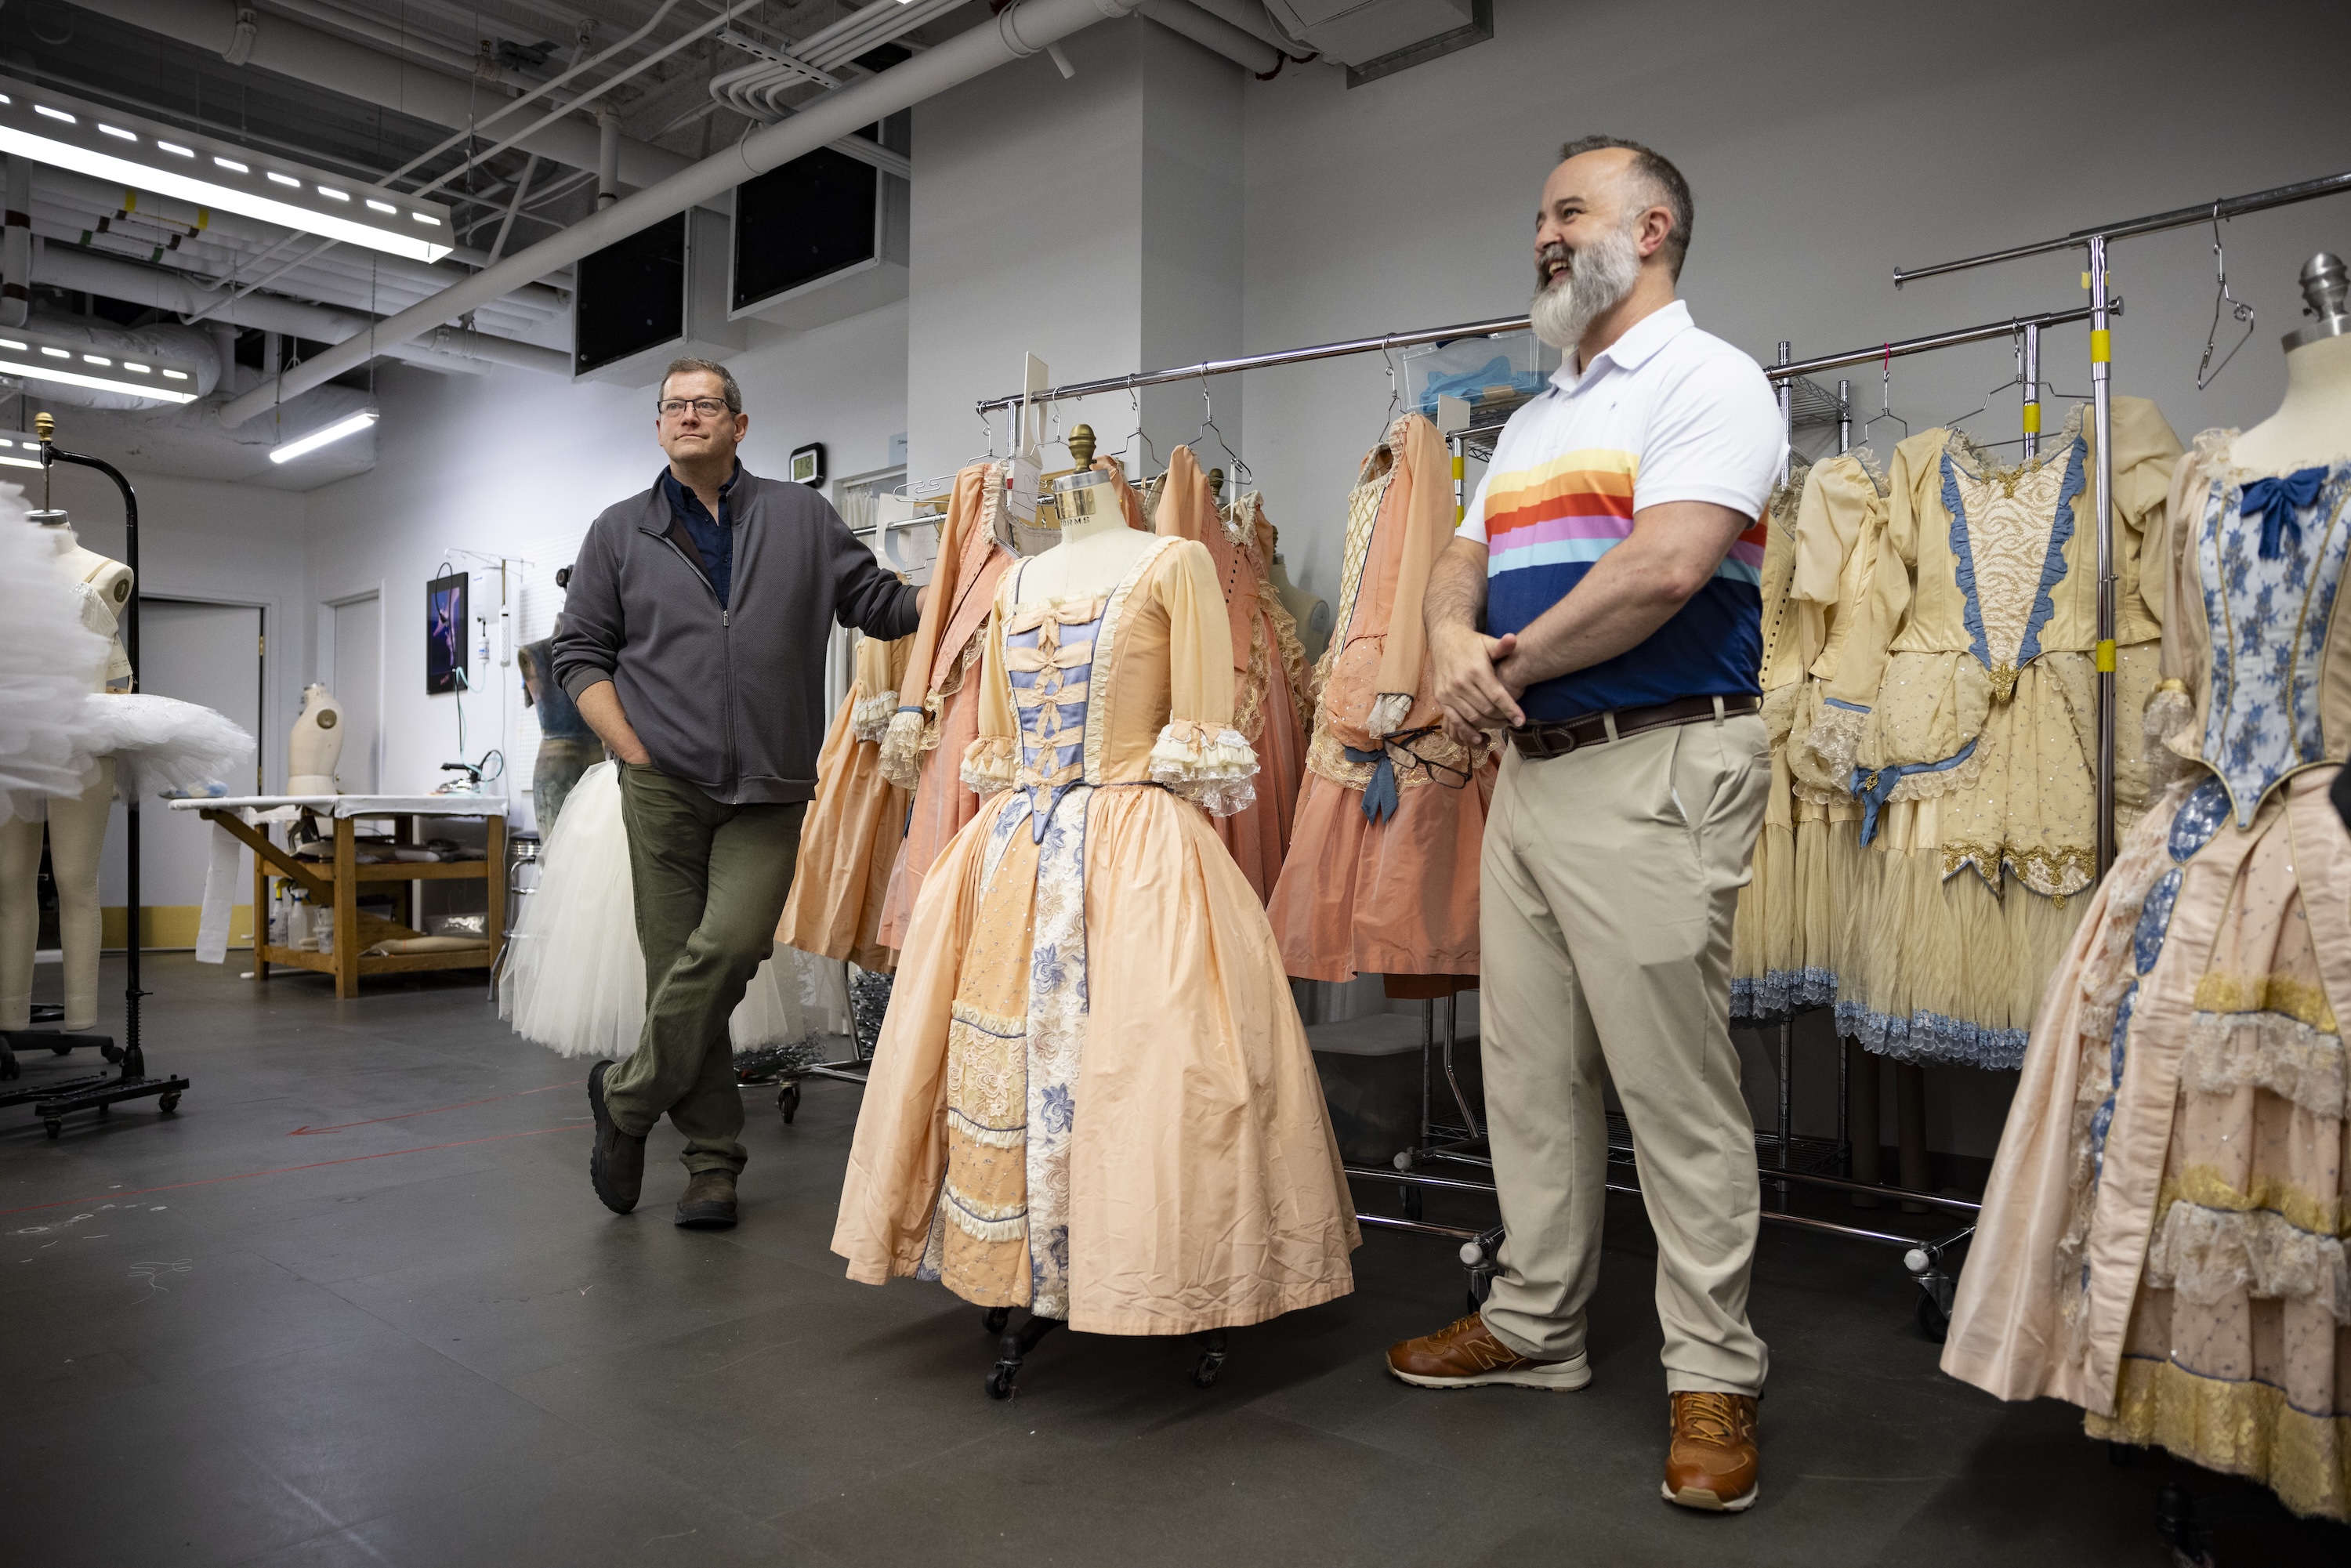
[73,0,694,212]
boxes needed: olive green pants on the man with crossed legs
[604,764,809,1173]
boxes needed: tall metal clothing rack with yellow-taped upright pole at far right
[1895,172,2351,877]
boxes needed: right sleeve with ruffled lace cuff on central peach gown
[1150,538,1258,816]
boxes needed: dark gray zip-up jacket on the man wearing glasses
[555,470,919,806]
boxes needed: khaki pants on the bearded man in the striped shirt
[1479,715,1770,1394]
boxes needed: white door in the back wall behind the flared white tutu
[103,597,261,947]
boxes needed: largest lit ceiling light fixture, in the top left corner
[0,78,451,261]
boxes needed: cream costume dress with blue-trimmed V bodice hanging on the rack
[1808,397,2179,1067]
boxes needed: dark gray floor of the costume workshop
[0,954,2351,1568]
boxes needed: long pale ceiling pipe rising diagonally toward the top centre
[221,0,1138,425]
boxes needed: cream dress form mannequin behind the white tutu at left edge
[0,512,132,1030]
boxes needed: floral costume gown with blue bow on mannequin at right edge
[1942,433,2351,1519]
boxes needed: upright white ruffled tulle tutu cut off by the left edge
[0,505,106,820]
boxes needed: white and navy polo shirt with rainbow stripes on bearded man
[1460,301,1787,722]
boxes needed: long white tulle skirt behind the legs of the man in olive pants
[498,762,849,1060]
